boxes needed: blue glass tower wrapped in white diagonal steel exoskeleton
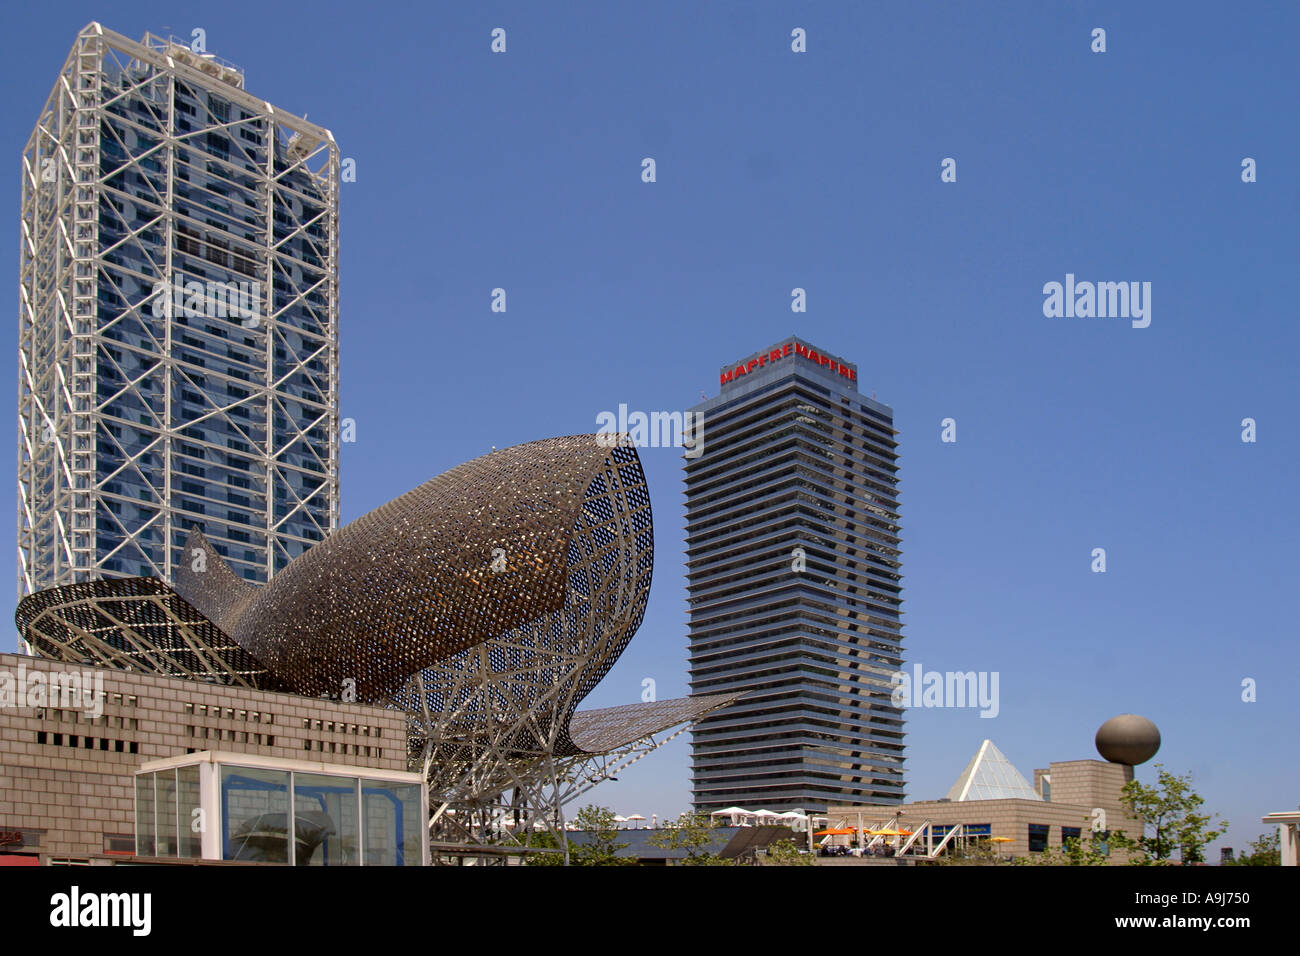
[18,23,339,606]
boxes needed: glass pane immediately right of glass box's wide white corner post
[221,766,289,864]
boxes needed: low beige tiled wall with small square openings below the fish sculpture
[0,654,407,862]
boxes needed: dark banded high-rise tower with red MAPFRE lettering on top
[685,337,904,812]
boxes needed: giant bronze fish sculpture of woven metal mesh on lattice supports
[16,434,735,858]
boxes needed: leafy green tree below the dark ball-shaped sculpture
[1110,763,1227,864]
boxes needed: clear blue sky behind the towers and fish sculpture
[0,0,1300,848]
